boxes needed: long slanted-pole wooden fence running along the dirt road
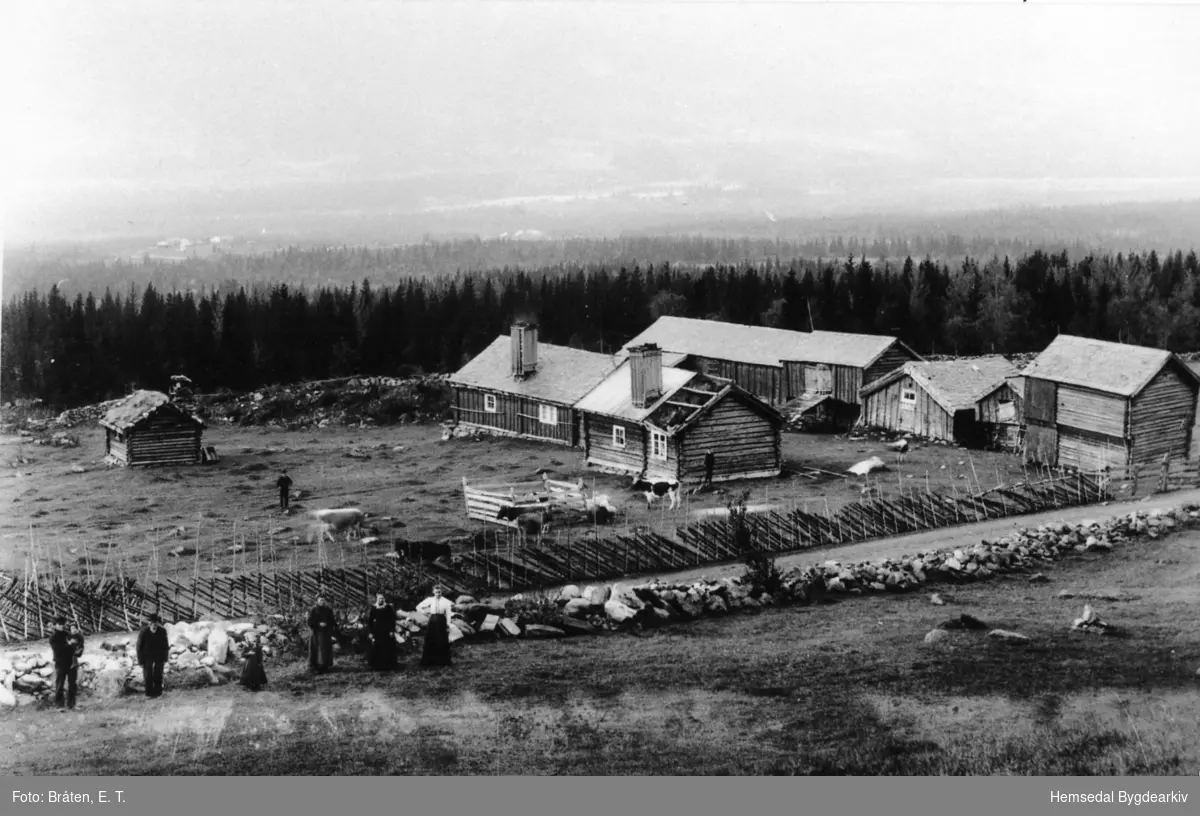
[0,463,1200,641]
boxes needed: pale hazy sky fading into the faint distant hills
[4,0,1200,233]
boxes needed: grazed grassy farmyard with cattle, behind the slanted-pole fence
[0,425,1026,577]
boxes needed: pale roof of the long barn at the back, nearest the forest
[622,316,916,368]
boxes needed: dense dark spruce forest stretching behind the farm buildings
[0,241,1200,407]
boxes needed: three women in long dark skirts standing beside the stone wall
[308,587,454,674]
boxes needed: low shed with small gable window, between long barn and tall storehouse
[859,356,1019,448]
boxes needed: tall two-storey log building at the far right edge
[1021,335,1200,470]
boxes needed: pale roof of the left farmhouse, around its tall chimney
[450,335,620,406]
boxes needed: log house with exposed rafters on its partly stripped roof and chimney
[575,344,784,481]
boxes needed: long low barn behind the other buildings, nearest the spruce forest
[625,317,922,421]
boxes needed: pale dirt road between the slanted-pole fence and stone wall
[600,490,1200,590]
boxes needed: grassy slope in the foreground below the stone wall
[0,525,1200,775]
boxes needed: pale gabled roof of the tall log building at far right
[1021,335,1200,397]
